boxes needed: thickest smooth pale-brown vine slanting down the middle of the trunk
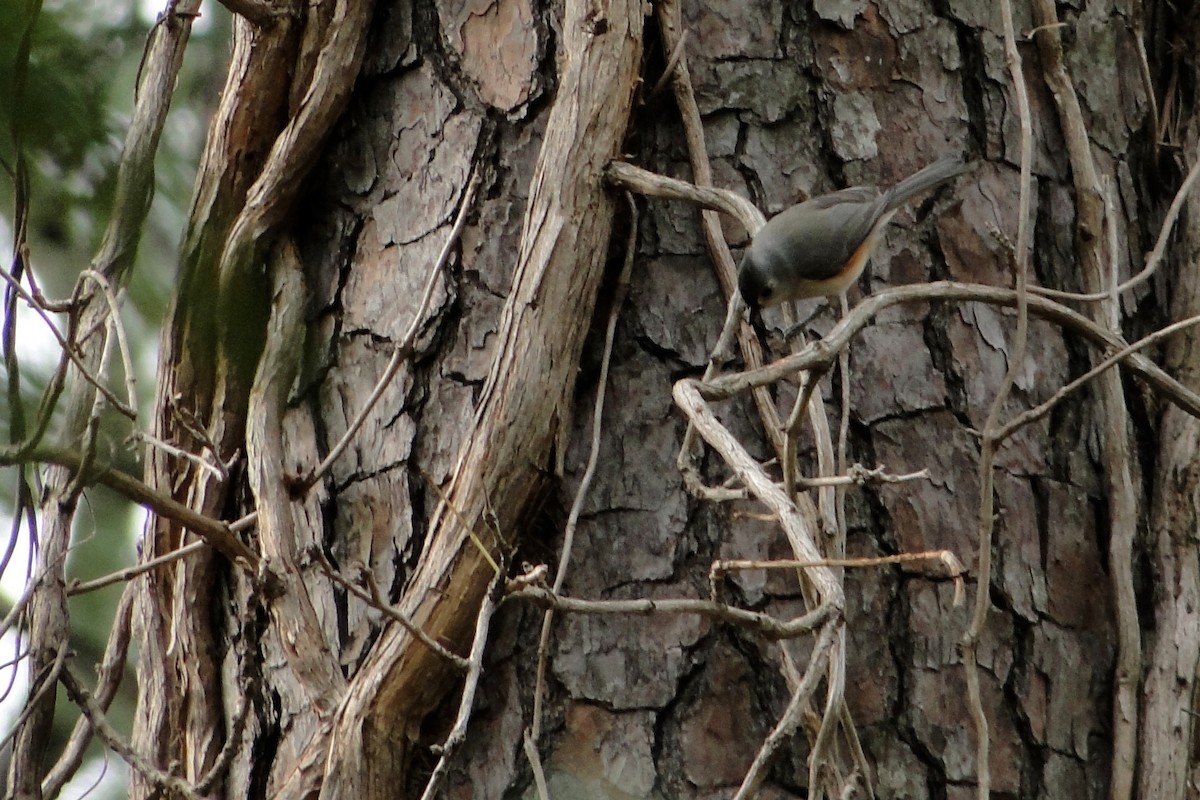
[312,0,643,798]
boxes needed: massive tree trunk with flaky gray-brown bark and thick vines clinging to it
[119,0,1200,800]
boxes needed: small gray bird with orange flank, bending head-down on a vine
[738,156,970,313]
